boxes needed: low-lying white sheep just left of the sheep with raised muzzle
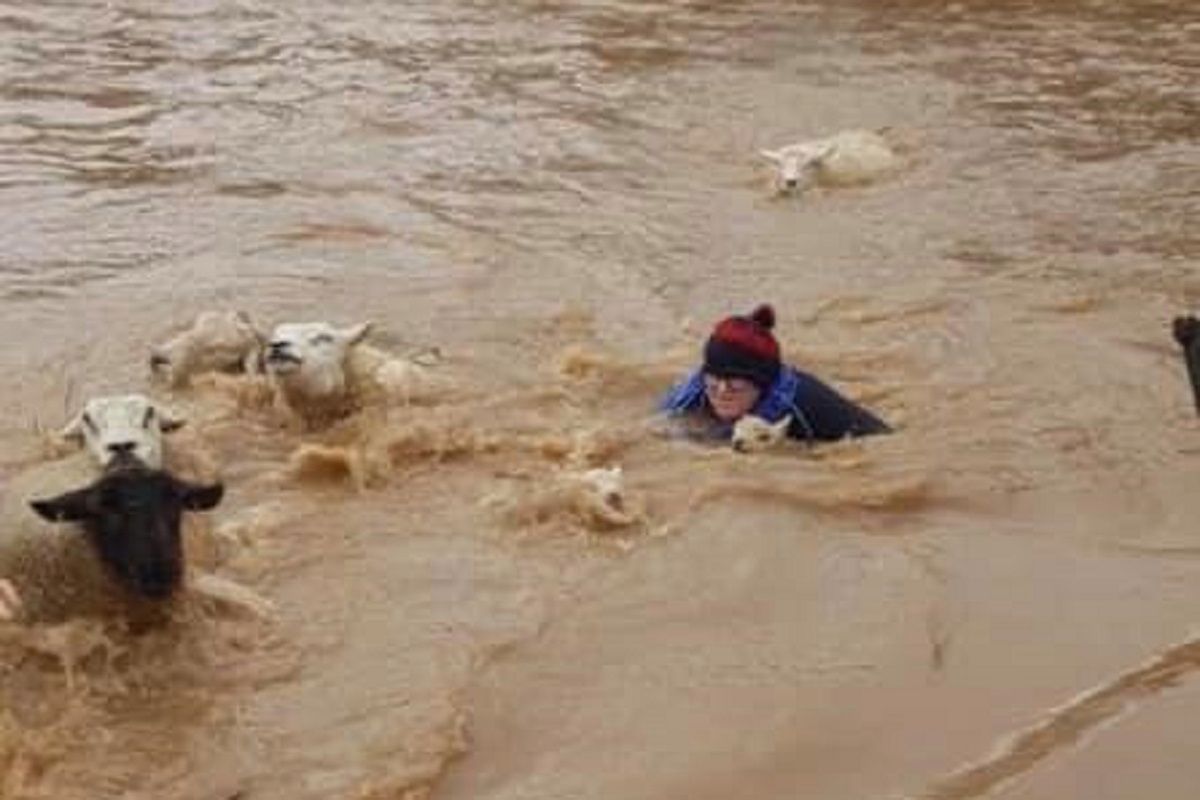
[150,311,266,386]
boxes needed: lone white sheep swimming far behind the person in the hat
[758,130,901,194]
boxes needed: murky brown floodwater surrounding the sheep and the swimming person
[0,0,1200,800]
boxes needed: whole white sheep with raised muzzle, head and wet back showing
[264,323,437,428]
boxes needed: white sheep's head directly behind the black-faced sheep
[61,395,185,469]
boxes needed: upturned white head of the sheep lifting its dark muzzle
[264,323,371,398]
